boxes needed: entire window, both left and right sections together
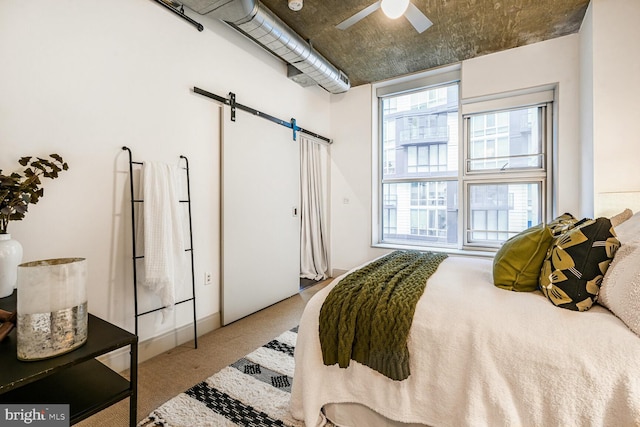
[374,67,553,250]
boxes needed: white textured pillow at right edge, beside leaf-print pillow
[598,241,640,336]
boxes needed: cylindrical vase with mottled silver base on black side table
[17,258,89,361]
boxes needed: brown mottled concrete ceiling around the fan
[261,0,589,86]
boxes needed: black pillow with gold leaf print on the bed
[540,218,620,311]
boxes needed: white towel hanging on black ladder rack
[142,162,185,314]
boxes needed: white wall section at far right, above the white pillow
[585,0,640,201]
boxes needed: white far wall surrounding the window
[331,35,582,270]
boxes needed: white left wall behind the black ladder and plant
[0,0,330,348]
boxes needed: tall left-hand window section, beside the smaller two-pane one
[380,82,460,245]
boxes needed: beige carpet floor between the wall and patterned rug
[76,280,330,427]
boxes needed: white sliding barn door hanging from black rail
[221,108,300,325]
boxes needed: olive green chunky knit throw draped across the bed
[319,251,447,381]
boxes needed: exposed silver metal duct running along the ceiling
[182,0,350,93]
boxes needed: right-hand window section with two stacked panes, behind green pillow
[463,103,548,247]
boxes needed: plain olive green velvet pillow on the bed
[493,224,553,292]
